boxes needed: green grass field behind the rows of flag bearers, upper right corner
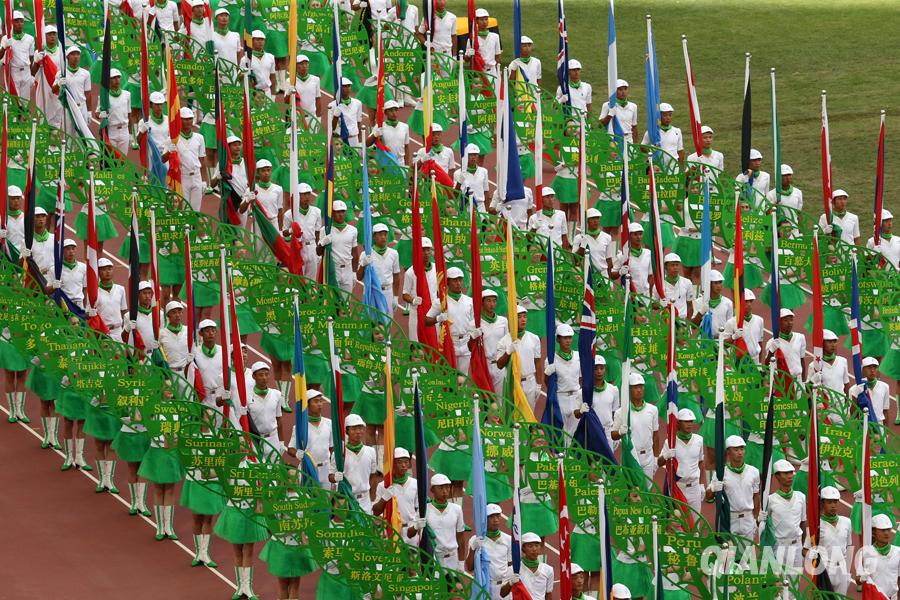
[474,0,900,224]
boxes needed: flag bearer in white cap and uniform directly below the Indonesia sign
[758,459,806,572]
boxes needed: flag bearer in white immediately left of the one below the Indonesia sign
[706,435,760,540]
